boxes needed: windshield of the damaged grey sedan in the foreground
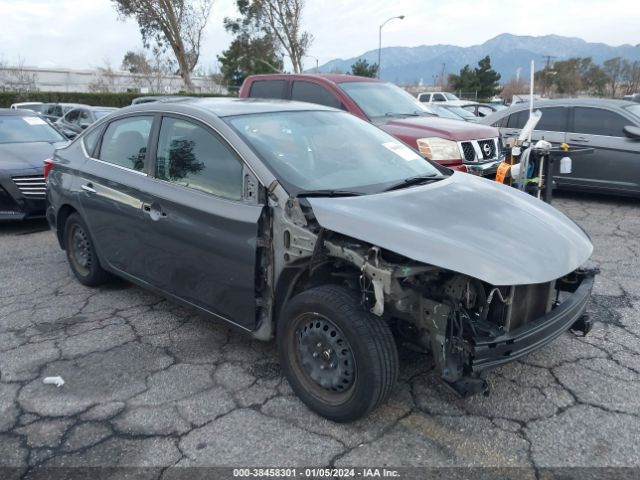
[225,111,446,195]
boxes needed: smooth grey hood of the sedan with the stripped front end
[308,172,593,285]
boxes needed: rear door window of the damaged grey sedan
[98,116,153,172]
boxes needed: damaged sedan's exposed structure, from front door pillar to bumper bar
[255,185,597,396]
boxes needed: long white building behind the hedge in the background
[0,66,227,94]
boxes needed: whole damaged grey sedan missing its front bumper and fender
[47,99,595,422]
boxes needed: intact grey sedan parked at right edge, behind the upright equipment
[480,98,640,195]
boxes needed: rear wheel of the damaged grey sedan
[64,213,111,287]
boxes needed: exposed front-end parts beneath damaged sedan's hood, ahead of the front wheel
[325,237,597,396]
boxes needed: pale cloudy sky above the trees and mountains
[0,0,640,71]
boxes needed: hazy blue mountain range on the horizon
[320,33,640,85]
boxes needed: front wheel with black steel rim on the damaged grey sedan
[277,285,398,423]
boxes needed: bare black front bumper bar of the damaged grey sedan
[471,276,594,373]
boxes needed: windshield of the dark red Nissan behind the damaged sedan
[339,82,429,118]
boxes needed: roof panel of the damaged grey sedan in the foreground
[122,97,340,117]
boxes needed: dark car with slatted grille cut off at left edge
[0,108,67,221]
